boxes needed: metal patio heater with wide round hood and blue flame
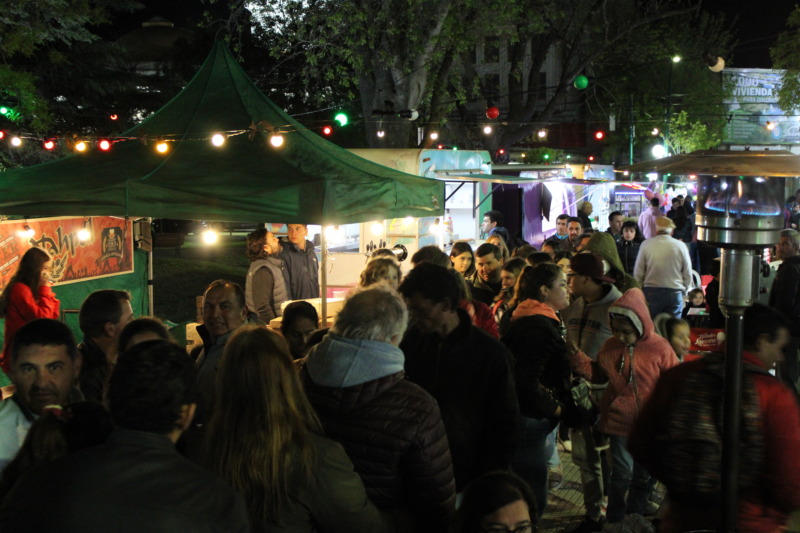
[623,150,800,532]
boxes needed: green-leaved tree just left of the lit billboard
[581,11,733,158]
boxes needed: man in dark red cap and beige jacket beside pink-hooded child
[561,252,622,532]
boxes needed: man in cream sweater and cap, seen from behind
[633,217,692,318]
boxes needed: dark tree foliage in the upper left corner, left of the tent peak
[0,0,139,167]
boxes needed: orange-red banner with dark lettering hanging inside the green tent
[0,217,133,291]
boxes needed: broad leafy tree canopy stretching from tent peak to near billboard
[249,0,727,156]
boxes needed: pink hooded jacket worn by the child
[569,289,679,437]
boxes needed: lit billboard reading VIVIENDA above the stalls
[723,68,800,145]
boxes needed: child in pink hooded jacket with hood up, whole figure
[567,288,678,527]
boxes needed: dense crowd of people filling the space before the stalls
[0,203,800,533]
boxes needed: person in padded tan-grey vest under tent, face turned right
[244,228,289,324]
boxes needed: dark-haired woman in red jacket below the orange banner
[0,247,61,372]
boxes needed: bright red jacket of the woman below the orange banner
[2,282,61,373]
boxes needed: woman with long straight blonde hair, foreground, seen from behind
[200,326,397,533]
